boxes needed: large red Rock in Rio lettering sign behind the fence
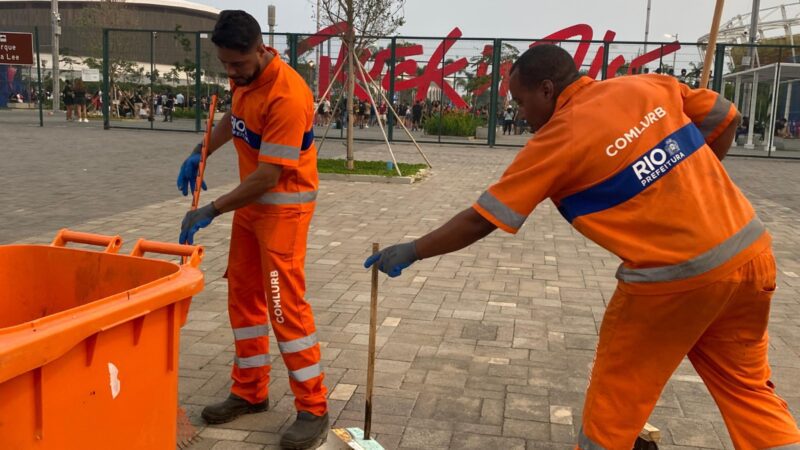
[298,22,681,109]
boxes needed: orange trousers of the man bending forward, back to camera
[578,249,800,450]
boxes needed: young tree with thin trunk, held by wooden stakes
[317,0,405,170]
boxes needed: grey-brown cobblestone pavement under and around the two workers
[0,113,800,450]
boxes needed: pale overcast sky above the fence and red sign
[193,0,798,42]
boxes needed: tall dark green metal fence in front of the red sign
[76,29,800,157]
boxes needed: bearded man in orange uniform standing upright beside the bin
[178,10,328,449]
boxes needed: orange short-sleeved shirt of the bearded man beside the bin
[231,47,319,211]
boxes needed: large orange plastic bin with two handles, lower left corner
[0,230,203,450]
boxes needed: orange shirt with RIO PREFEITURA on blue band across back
[473,75,770,293]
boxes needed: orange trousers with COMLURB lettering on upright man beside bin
[227,205,328,416]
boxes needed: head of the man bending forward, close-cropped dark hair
[510,45,580,132]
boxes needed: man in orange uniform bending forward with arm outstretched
[365,45,800,450]
